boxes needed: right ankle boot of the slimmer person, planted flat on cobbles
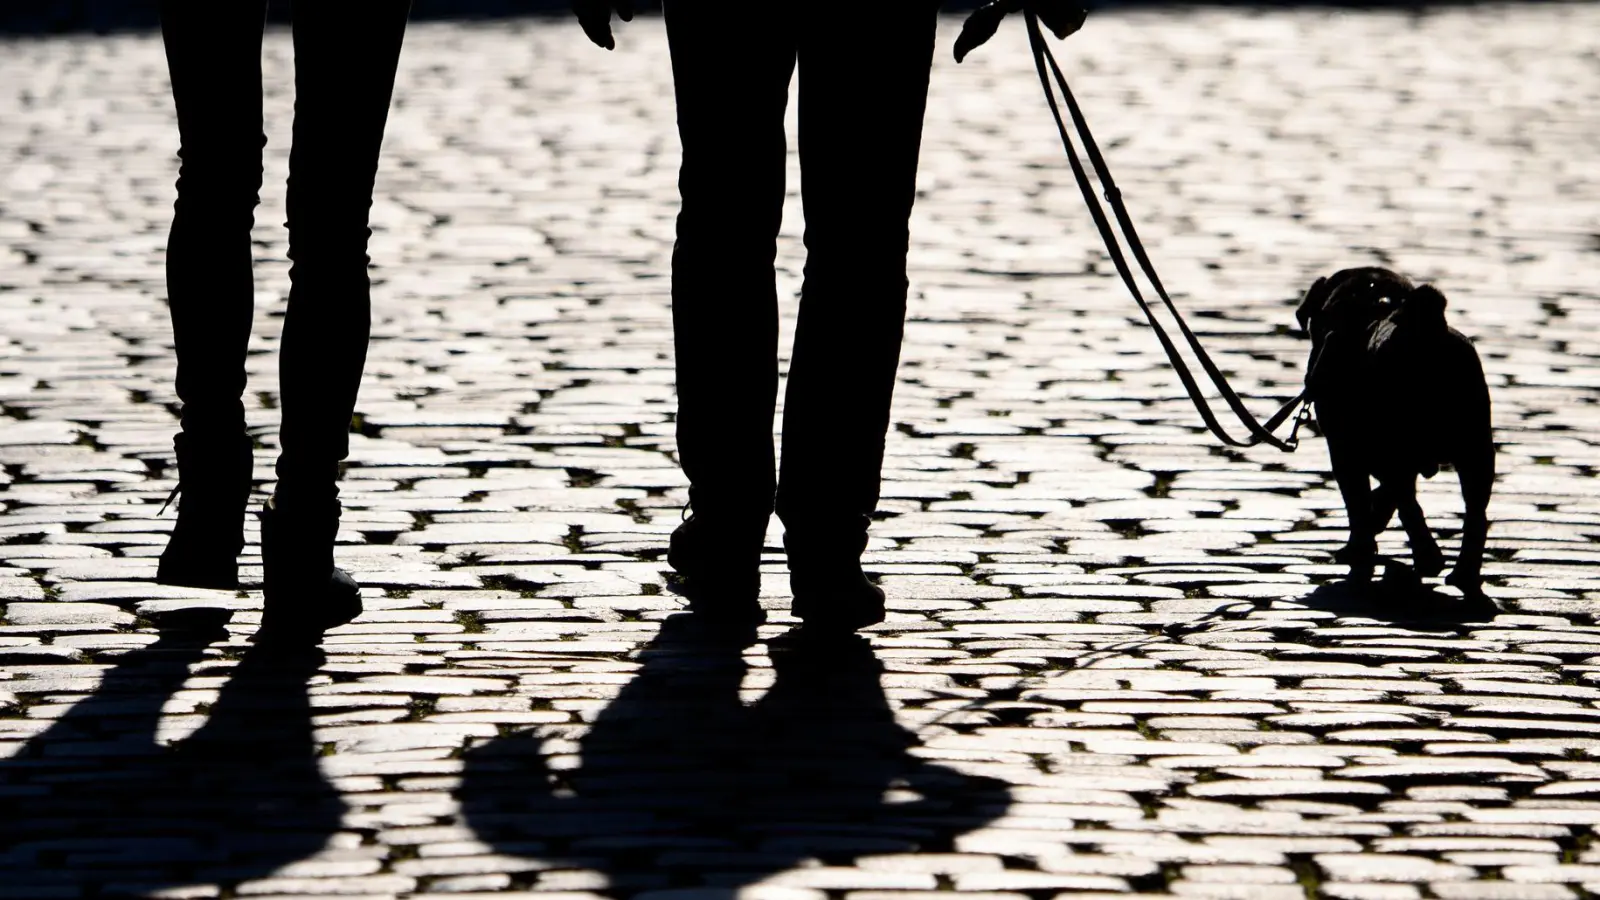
[254,496,362,642]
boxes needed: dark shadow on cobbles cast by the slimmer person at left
[0,610,346,897]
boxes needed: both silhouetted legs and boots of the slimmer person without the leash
[162,0,410,634]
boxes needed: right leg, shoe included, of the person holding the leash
[778,2,938,628]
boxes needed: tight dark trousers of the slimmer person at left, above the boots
[162,0,410,498]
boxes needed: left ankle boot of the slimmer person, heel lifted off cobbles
[155,432,253,591]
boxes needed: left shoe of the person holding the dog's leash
[667,514,766,625]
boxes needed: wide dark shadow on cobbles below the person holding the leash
[459,615,1010,897]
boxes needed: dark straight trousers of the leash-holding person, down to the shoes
[666,0,938,552]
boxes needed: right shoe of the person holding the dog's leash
[784,524,886,633]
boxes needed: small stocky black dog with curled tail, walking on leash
[1294,267,1494,594]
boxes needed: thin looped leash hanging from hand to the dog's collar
[1024,11,1310,453]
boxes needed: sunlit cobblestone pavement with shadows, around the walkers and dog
[0,5,1600,900]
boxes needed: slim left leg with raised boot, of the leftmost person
[157,0,266,589]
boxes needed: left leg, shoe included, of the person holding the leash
[666,0,795,609]
